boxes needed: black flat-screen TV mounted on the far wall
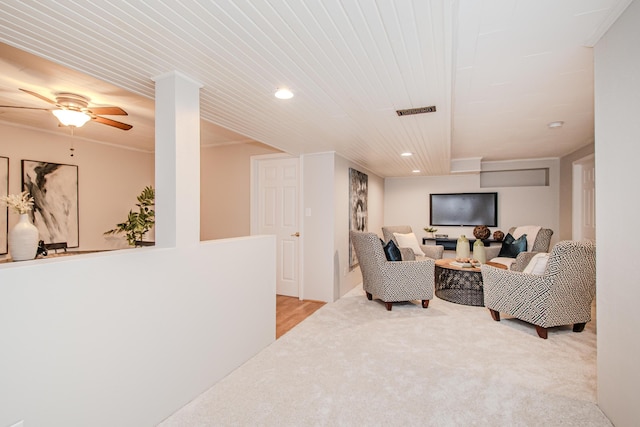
[429,193,498,227]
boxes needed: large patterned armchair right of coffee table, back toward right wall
[482,240,596,339]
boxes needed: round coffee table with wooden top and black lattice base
[435,258,507,307]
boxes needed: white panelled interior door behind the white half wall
[257,157,300,297]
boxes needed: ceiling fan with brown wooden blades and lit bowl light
[0,89,133,130]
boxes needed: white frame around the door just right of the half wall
[249,153,304,301]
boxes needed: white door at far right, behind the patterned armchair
[572,156,596,242]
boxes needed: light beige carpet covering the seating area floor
[161,288,611,427]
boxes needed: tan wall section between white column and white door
[200,142,281,240]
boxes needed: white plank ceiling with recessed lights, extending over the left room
[0,0,631,177]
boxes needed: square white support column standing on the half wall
[154,71,202,248]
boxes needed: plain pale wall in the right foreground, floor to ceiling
[595,0,640,427]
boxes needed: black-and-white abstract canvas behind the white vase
[22,160,79,248]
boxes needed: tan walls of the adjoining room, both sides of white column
[0,122,280,254]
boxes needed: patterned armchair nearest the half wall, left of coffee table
[350,231,435,311]
